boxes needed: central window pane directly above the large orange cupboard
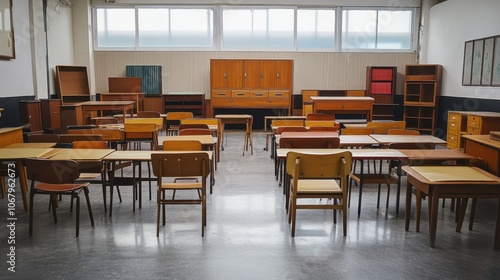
[222,8,295,50]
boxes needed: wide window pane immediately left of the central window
[138,8,214,48]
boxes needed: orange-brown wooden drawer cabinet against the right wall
[447,111,500,149]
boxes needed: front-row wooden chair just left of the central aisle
[151,152,210,237]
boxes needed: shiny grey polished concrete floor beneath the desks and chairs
[0,131,500,279]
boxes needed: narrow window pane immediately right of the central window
[297,9,335,50]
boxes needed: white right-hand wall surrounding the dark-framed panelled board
[420,0,500,100]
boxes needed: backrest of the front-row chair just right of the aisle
[286,151,352,183]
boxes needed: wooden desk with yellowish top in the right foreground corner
[403,166,500,250]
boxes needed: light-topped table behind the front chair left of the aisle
[103,151,214,217]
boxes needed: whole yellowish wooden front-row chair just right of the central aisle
[286,151,352,237]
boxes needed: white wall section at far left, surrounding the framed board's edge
[0,0,34,97]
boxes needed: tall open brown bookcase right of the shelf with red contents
[403,64,442,135]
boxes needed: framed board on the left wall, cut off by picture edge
[0,0,16,59]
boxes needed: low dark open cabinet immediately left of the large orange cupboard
[163,92,205,118]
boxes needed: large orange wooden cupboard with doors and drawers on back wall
[210,59,293,115]
